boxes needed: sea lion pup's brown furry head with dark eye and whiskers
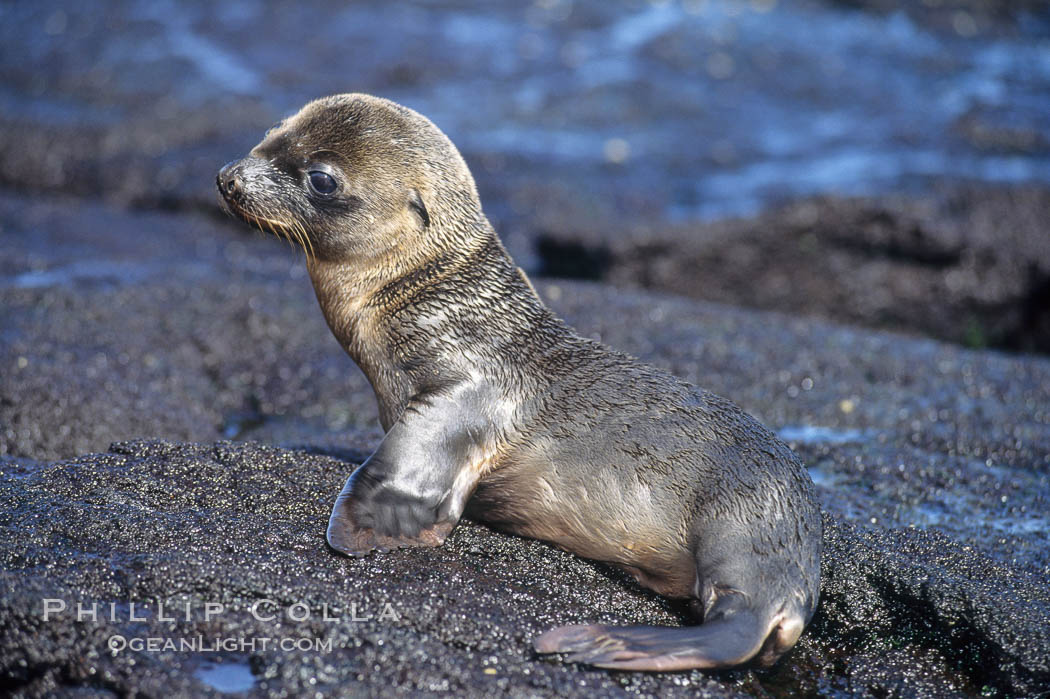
[216,94,481,264]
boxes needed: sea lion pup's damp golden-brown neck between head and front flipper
[308,225,550,428]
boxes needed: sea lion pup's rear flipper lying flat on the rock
[533,594,809,672]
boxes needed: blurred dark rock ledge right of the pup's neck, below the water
[539,187,1050,354]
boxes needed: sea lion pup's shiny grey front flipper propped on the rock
[328,385,491,556]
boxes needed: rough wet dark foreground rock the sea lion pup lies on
[0,442,1050,696]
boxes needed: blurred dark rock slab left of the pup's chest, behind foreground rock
[0,196,381,459]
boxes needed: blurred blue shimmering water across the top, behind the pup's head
[0,0,1050,220]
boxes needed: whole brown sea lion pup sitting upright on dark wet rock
[217,94,821,671]
